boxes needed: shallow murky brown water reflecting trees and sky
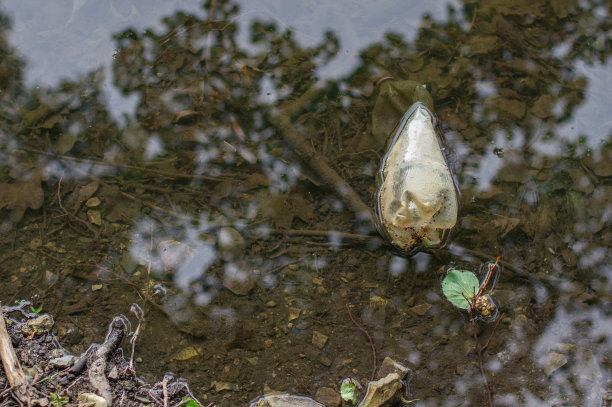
[0,0,612,406]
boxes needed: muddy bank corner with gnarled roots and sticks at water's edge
[0,301,207,407]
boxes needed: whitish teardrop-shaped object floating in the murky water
[375,102,459,254]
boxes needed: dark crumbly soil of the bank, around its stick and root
[0,302,206,407]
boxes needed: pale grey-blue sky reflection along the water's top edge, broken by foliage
[2,0,448,118]
